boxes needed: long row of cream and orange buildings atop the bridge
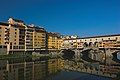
[63,34,120,49]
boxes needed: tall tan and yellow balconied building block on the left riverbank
[0,18,47,54]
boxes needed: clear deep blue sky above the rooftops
[0,0,120,37]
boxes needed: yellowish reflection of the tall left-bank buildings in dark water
[0,59,63,80]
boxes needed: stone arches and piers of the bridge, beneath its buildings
[59,46,120,64]
